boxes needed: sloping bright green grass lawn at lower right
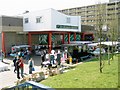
[40,54,120,88]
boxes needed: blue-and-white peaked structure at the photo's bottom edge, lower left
[4,81,55,90]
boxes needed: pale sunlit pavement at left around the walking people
[0,56,41,90]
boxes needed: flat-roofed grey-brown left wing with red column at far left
[0,16,27,54]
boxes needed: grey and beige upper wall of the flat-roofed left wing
[0,16,23,32]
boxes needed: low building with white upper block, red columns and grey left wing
[0,9,94,55]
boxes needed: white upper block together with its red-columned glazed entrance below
[23,8,81,52]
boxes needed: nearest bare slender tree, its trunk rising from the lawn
[96,3,105,73]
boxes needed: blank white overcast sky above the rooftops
[0,0,109,15]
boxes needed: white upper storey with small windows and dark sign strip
[23,9,81,32]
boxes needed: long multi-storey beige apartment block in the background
[58,0,120,40]
